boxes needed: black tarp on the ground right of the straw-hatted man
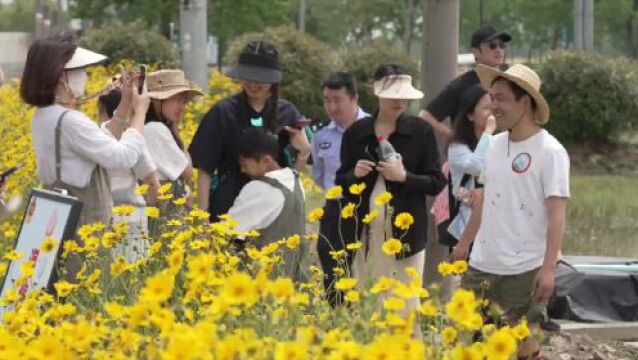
[547,256,638,322]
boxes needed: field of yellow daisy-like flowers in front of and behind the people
[0,69,531,360]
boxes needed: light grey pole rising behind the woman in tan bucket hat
[179,0,208,91]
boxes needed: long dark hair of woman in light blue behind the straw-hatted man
[451,84,487,150]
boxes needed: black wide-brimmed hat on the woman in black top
[226,41,282,84]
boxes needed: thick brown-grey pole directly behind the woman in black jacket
[421,0,459,295]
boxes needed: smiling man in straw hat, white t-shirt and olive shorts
[452,65,569,359]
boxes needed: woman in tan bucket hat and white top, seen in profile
[144,70,202,197]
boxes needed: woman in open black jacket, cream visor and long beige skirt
[336,64,445,304]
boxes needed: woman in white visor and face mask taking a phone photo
[20,36,149,280]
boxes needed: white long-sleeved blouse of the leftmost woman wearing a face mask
[31,104,144,188]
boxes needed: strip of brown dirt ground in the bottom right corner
[542,333,638,360]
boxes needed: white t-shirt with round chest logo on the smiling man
[470,129,569,275]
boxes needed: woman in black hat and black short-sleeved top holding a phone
[188,41,310,221]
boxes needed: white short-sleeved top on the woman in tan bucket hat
[144,121,190,181]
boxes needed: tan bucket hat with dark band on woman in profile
[146,69,204,100]
